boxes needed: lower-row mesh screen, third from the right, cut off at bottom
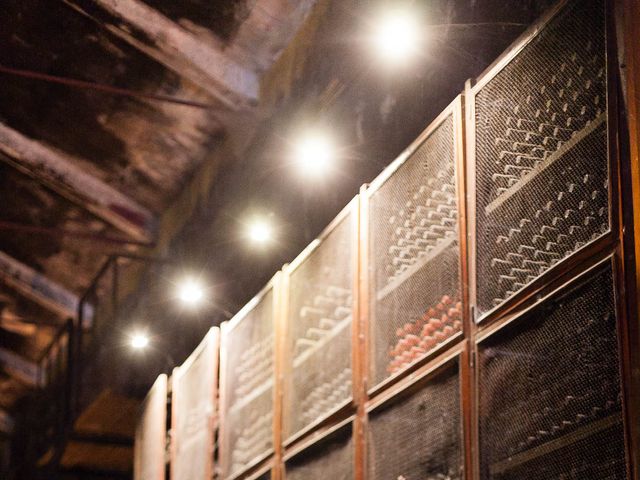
[285,425,354,480]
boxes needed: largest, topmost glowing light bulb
[373,11,420,64]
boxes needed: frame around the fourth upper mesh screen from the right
[218,272,281,480]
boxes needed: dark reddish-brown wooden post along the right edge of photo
[607,0,640,480]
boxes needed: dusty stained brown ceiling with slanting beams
[0,0,313,474]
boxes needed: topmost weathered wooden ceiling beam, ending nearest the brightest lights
[64,0,260,110]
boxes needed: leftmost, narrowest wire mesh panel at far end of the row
[133,374,167,480]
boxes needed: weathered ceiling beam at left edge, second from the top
[0,123,155,241]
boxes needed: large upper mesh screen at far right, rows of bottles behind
[475,0,610,313]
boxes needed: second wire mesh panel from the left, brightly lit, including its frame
[171,328,219,480]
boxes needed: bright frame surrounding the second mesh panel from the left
[170,327,220,480]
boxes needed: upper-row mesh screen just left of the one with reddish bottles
[285,214,353,436]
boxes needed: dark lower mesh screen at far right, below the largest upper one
[478,265,627,479]
